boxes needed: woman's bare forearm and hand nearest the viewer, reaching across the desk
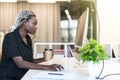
[13,56,64,71]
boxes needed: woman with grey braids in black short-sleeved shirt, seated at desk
[0,10,63,80]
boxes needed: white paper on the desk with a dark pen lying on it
[32,71,75,80]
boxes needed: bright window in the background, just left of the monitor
[60,19,77,42]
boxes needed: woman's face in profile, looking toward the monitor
[25,17,37,34]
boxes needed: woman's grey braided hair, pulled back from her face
[11,10,36,31]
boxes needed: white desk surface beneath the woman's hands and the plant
[21,57,120,80]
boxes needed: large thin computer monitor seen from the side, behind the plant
[74,7,89,52]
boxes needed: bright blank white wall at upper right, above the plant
[97,0,120,43]
